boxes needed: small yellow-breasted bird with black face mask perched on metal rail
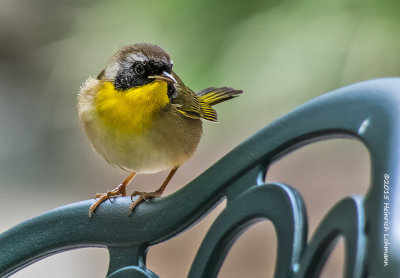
[77,43,242,217]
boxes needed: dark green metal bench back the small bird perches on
[0,78,400,278]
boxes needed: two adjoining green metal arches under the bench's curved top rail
[189,179,366,278]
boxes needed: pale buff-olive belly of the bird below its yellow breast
[86,112,201,173]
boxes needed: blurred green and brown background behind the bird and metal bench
[0,0,400,278]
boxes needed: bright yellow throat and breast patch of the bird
[95,81,169,134]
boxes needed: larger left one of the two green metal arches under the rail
[189,184,307,278]
